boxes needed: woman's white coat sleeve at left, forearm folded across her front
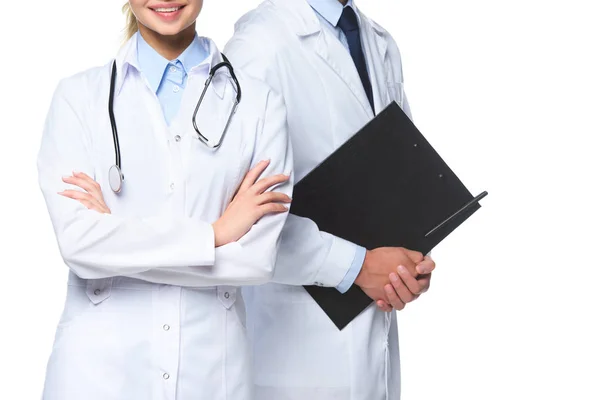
[37,82,215,279]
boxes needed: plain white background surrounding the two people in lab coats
[0,0,600,400]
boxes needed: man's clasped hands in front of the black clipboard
[355,247,435,311]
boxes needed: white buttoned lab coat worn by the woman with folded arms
[38,39,292,400]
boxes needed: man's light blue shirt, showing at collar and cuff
[307,0,367,293]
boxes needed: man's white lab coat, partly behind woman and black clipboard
[225,0,410,400]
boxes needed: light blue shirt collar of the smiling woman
[136,32,209,93]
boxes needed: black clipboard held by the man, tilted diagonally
[290,102,487,329]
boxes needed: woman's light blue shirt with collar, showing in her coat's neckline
[136,32,209,125]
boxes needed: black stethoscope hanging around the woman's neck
[108,54,242,193]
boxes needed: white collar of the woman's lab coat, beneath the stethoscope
[115,35,227,99]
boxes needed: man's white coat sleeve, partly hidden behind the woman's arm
[225,29,362,291]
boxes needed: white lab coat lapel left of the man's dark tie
[273,0,373,119]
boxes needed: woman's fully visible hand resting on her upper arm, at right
[213,161,292,247]
